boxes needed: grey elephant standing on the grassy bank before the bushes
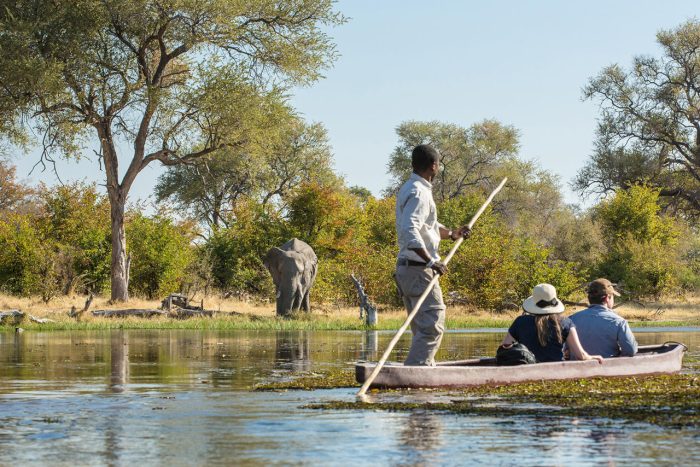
[263,238,318,316]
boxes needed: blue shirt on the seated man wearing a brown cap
[571,305,637,358]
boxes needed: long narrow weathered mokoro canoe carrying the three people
[355,342,687,388]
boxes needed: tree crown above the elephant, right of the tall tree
[156,116,333,230]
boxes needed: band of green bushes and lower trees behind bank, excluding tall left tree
[0,120,700,310]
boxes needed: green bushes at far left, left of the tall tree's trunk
[0,183,110,301]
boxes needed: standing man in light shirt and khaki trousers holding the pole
[396,144,469,366]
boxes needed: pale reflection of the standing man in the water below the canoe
[399,411,442,465]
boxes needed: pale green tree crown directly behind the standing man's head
[387,120,518,202]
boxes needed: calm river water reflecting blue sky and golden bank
[0,330,700,465]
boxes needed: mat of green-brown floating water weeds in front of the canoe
[306,374,700,427]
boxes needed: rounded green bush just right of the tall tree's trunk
[126,214,194,299]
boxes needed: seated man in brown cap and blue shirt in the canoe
[571,279,637,358]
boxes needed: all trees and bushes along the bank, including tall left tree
[0,4,700,309]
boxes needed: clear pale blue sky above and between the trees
[5,0,700,205]
